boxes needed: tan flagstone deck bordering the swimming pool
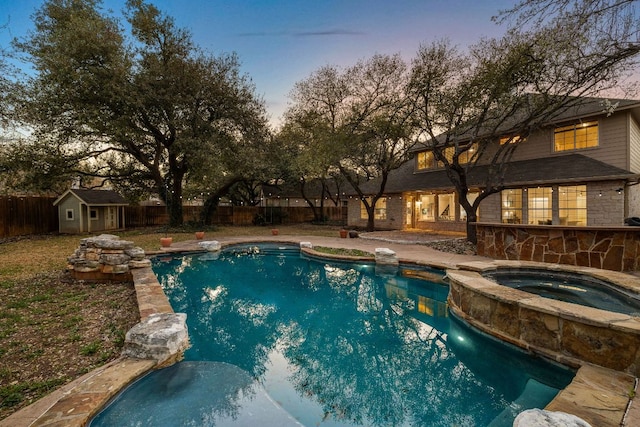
[0,232,640,427]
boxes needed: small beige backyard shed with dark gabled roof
[53,188,128,234]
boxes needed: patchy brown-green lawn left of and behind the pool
[0,225,338,419]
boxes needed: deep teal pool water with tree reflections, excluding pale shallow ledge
[154,254,571,426]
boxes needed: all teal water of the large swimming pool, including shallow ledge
[91,245,574,427]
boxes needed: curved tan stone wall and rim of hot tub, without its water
[447,261,640,376]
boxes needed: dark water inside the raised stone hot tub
[485,268,640,316]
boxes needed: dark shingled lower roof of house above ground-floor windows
[363,154,638,193]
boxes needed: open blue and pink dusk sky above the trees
[0,0,514,124]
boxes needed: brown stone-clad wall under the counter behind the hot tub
[476,223,640,271]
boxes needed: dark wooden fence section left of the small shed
[0,196,58,238]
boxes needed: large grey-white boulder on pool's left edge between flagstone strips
[122,313,189,367]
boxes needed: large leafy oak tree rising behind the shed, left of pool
[17,0,267,225]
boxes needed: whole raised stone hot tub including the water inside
[447,260,640,376]
